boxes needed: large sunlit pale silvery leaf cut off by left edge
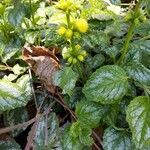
[0,75,31,111]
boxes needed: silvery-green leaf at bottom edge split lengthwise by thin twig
[33,113,62,150]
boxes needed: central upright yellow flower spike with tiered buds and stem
[55,0,89,64]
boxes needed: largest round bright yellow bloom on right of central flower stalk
[75,18,89,33]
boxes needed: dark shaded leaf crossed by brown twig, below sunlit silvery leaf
[3,107,29,137]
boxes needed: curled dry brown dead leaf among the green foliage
[22,46,59,93]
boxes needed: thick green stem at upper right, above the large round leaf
[118,0,142,64]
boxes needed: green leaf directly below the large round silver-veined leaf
[75,100,106,128]
